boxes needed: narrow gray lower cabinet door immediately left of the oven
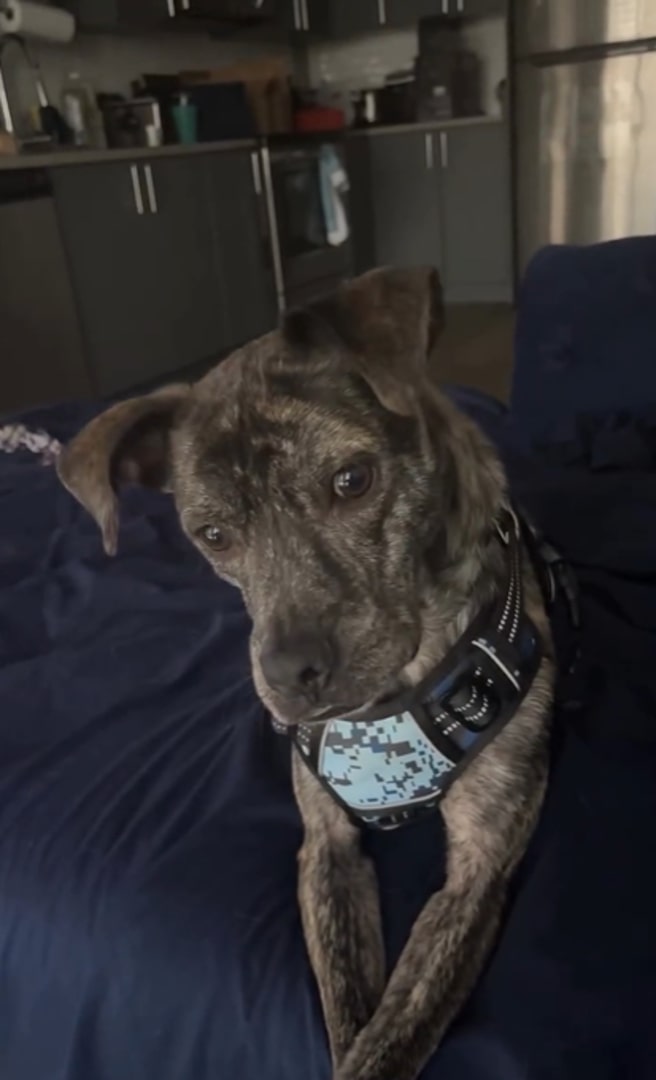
[205,150,278,349]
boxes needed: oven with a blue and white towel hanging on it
[263,138,352,310]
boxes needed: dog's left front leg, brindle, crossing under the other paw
[294,751,385,1067]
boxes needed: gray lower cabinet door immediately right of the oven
[347,131,443,273]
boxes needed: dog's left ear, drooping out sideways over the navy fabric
[57,386,189,555]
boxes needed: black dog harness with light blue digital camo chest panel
[292,511,564,829]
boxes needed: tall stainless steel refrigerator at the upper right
[513,0,656,270]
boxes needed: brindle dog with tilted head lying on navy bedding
[58,268,554,1080]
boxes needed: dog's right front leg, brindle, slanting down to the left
[336,737,546,1080]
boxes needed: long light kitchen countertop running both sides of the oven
[0,116,504,171]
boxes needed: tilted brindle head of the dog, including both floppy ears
[59,270,503,723]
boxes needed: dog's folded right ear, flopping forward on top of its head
[283,267,444,416]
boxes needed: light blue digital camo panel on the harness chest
[319,713,454,810]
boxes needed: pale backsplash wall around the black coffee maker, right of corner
[307,16,508,114]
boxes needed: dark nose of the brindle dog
[259,632,335,700]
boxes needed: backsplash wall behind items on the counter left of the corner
[32,33,291,102]
